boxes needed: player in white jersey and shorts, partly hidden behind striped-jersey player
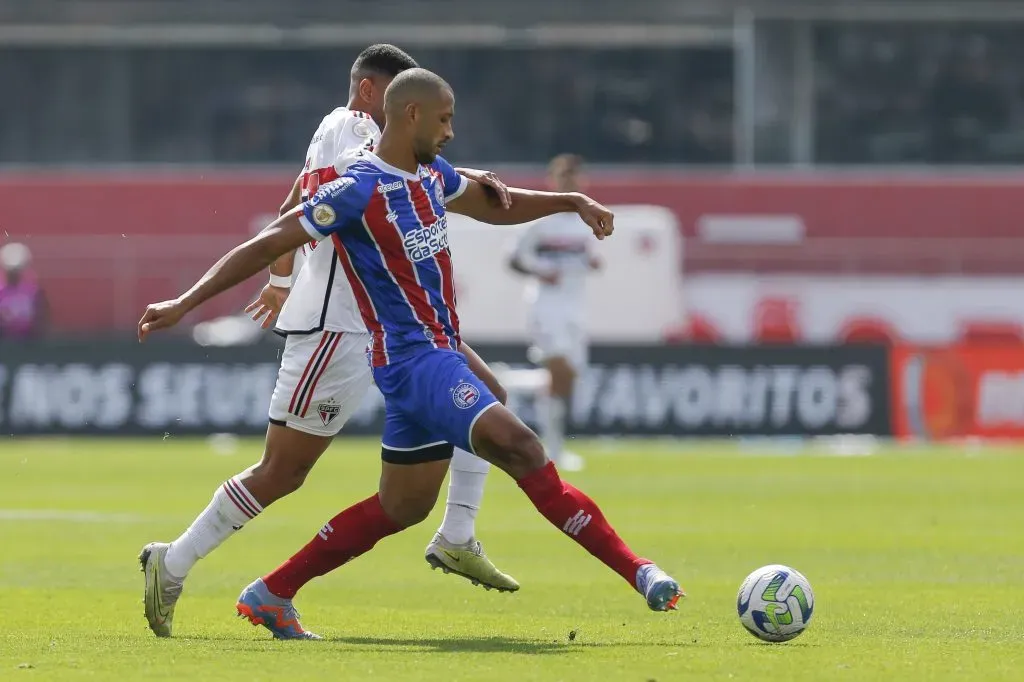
[139,45,519,637]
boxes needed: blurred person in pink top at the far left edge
[0,242,48,341]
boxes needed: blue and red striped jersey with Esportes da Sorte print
[299,152,467,367]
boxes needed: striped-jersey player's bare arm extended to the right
[446,178,615,240]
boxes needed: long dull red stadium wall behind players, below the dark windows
[6,170,1024,332]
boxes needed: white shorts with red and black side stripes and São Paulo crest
[270,332,373,436]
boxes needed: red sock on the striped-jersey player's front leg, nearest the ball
[519,462,650,589]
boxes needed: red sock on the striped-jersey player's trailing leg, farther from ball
[263,495,401,599]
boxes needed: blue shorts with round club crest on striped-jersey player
[373,350,499,464]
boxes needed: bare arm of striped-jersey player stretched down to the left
[138,209,309,341]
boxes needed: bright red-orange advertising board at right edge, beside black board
[891,344,1024,440]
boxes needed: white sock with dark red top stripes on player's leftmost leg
[164,476,263,578]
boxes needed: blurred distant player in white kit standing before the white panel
[510,154,600,471]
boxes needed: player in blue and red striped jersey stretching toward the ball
[138,69,682,639]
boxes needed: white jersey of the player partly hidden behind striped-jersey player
[274,106,380,335]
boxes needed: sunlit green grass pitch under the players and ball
[0,438,1024,682]
